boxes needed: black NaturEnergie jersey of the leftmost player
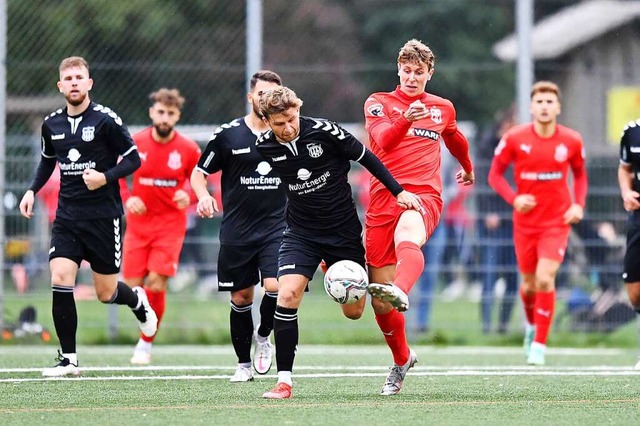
[42,102,138,219]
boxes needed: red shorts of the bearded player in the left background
[122,221,185,279]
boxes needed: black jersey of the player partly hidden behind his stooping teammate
[197,118,286,245]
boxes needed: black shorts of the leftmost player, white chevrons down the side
[49,217,123,275]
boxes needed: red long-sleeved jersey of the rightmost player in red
[490,123,587,228]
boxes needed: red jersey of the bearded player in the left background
[120,127,200,232]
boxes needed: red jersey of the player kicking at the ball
[364,88,457,200]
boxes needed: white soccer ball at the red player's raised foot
[324,260,369,305]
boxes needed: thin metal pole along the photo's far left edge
[0,0,7,329]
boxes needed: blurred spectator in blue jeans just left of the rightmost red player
[476,106,518,334]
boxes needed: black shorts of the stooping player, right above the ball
[278,227,366,279]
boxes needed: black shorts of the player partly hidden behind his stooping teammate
[218,238,280,291]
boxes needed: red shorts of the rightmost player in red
[513,226,571,274]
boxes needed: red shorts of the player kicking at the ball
[364,191,442,268]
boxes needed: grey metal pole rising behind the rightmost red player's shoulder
[516,0,533,123]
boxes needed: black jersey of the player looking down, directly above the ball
[257,116,366,235]
